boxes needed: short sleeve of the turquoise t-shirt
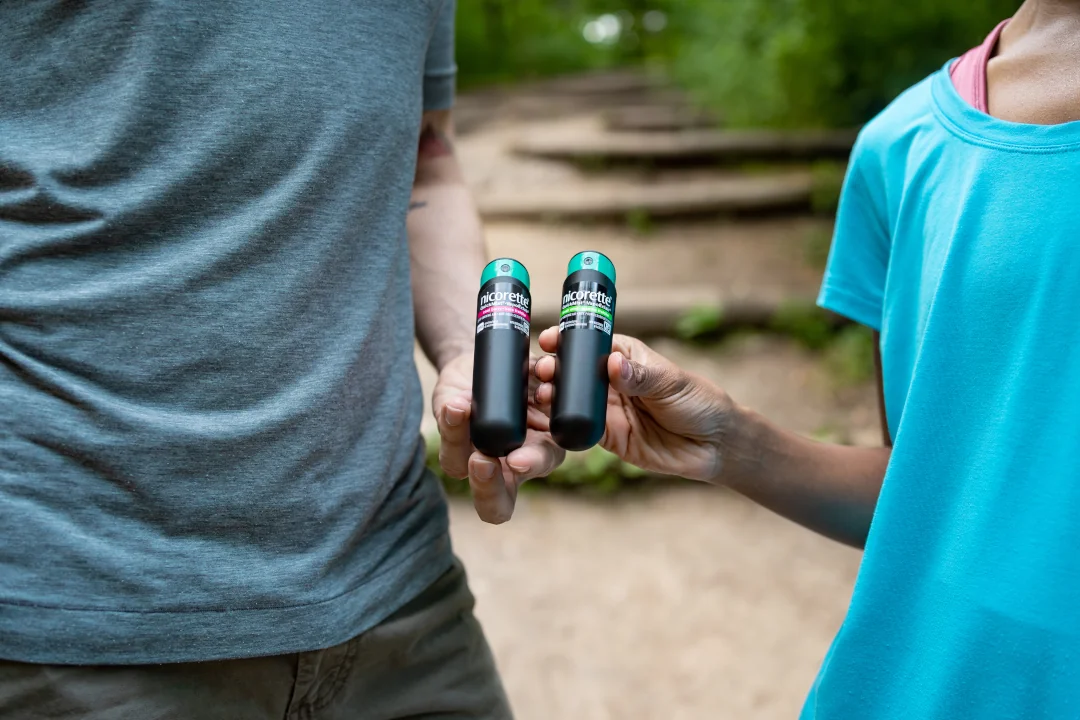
[818,142,890,330]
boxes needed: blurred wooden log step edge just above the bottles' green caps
[477,171,813,220]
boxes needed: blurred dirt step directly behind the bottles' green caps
[486,218,831,335]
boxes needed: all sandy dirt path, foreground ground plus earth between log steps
[429,76,879,720]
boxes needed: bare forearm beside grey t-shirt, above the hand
[408,117,487,368]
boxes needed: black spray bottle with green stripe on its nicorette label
[551,252,616,450]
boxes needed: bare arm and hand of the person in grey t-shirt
[406,110,566,524]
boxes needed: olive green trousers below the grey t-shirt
[0,565,512,720]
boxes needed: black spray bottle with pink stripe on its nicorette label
[469,258,532,458]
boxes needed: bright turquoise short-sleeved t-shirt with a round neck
[802,63,1080,720]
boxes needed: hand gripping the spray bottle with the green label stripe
[535,327,734,481]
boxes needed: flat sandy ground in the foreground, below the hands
[451,487,860,720]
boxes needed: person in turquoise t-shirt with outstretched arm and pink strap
[509,0,1080,720]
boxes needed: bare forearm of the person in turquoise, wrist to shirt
[719,408,891,547]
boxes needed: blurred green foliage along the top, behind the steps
[458,0,1020,126]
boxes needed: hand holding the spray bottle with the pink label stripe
[431,353,566,525]
